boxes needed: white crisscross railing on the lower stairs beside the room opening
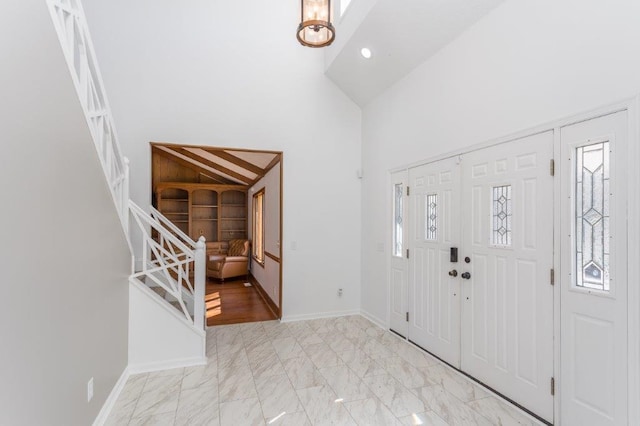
[129,201,206,330]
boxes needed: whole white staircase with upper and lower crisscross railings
[46,0,206,372]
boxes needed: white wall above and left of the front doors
[362,0,640,322]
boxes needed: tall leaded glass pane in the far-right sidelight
[575,142,609,291]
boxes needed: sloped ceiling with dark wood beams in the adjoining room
[151,143,281,186]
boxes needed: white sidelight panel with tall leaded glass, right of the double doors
[559,111,637,425]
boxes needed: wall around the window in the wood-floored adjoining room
[247,164,280,306]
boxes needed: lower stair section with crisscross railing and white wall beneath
[129,202,206,372]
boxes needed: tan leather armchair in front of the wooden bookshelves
[207,240,249,281]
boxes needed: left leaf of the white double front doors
[409,159,461,367]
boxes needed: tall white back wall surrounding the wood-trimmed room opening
[83,0,361,317]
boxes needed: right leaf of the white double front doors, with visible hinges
[459,131,553,421]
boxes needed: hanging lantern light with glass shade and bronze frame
[297,0,336,47]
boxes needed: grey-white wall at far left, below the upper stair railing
[0,0,131,425]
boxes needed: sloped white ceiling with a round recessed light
[326,0,504,107]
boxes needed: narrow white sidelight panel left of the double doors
[389,170,409,337]
